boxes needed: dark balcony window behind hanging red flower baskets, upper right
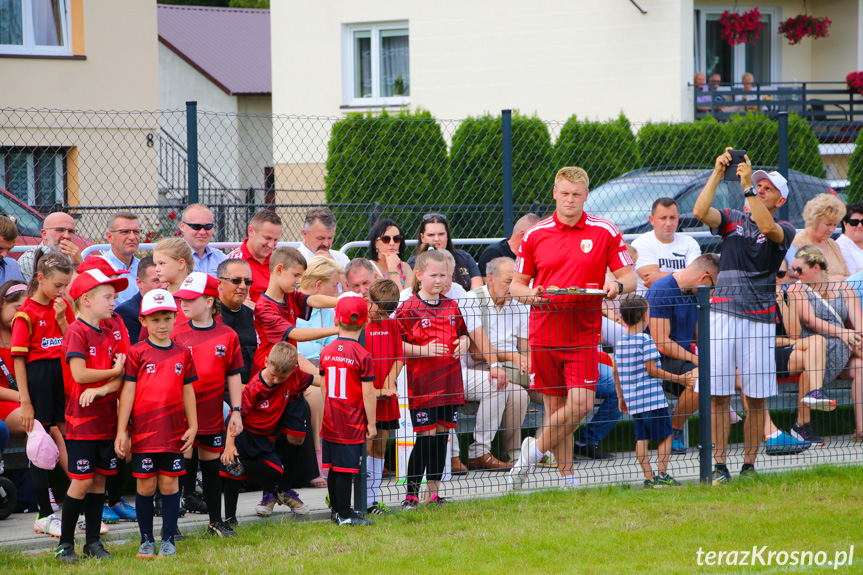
[694,6,781,84]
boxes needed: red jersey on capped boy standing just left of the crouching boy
[171,321,243,435]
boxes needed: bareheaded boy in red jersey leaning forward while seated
[221,340,319,525]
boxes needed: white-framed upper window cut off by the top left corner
[0,0,72,56]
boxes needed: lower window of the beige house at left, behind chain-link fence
[0,147,66,213]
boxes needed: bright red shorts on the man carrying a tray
[530,347,599,397]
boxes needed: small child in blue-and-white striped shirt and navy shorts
[614,294,698,489]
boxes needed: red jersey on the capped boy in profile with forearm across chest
[63,319,121,440]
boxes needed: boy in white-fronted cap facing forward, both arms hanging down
[114,289,198,558]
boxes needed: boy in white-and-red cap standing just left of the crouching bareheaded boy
[172,272,243,537]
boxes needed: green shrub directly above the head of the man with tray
[546,114,641,189]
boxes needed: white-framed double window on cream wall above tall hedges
[342,22,411,106]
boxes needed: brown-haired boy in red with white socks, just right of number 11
[366,278,405,515]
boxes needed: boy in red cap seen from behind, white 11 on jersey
[321,292,377,526]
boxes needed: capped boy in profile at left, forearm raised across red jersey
[54,269,129,563]
